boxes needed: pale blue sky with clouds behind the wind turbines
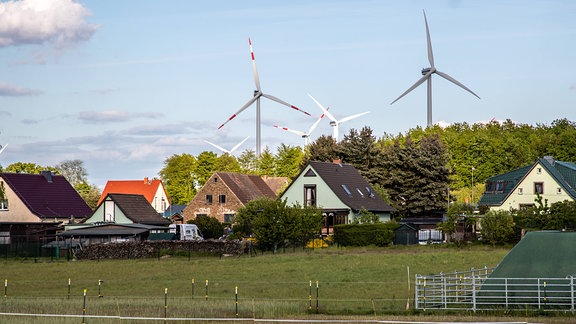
[0,0,576,188]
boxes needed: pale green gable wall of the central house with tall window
[280,166,354,221]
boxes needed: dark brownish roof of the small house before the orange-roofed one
[101,193,170,225]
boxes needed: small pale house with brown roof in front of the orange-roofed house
[59,194,171,244]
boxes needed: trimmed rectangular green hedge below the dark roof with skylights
[334,221,398,246]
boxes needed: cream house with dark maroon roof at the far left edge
[0,171,92,223]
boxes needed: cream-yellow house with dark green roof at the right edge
[478,156,576,210]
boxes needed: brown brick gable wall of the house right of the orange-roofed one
[182,174,244,223]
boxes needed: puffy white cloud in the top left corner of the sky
[0,0,98,48]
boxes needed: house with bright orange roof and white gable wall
[98,177,170,214]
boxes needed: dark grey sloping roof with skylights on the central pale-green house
[304,161,396,212]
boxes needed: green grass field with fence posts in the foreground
[0,245,574,323]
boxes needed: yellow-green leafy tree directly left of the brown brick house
[158,153,196,204]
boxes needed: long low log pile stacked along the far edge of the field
[75,240,246,260]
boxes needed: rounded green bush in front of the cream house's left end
[480,210,514,245]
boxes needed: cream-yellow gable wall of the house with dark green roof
[490,163,573,210]
